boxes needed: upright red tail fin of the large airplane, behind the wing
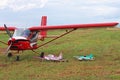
[40,16,47,40]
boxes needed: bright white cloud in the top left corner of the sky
[0,0,47,11]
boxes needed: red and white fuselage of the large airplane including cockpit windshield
[8,28,37,50]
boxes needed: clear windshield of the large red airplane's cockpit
[13,28,30,38]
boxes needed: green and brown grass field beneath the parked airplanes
[0,29,120,80]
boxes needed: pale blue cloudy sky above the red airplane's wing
[0,0,120,27]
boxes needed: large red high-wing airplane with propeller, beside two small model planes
[0,16,118,58]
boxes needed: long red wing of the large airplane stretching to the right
[29,22,118,31]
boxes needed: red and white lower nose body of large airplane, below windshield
[8,37,37,50]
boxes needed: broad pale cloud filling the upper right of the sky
[49,0,120,16]
